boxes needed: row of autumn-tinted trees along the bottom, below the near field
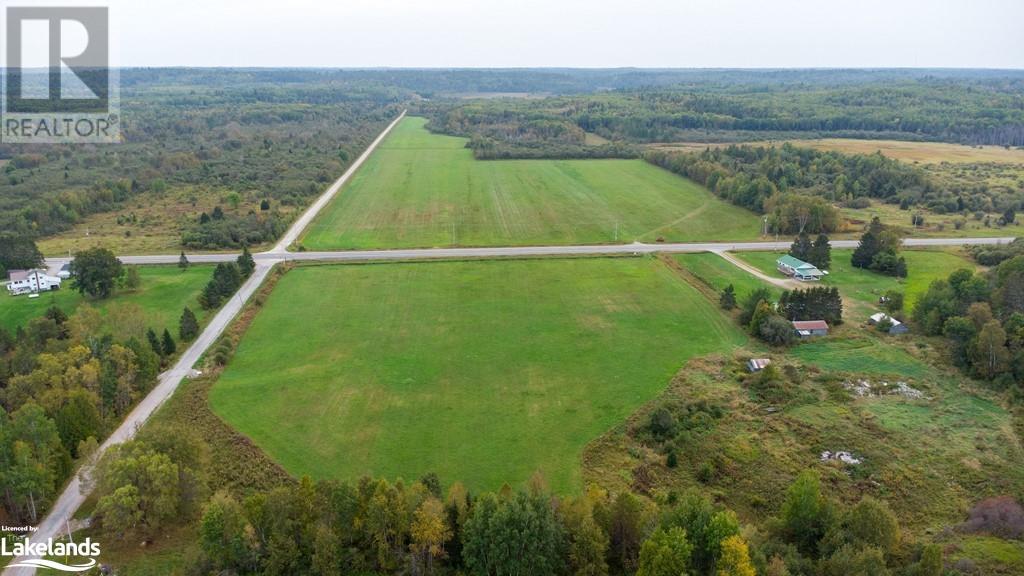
[93,425,942,576]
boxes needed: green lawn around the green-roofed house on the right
[736,250,977,313]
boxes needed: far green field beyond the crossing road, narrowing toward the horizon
[301,118,760,250]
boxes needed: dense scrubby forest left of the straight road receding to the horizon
[0,73,408,243]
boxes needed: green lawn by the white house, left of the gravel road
[0,265,213,334]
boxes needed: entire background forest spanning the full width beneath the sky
[0,69,1024,249]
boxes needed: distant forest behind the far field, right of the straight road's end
[418,71,1024,158]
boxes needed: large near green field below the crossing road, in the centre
[210,257,745,492]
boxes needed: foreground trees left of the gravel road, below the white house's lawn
[0,248,255,523]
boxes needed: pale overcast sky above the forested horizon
[54,0,1024,69]
